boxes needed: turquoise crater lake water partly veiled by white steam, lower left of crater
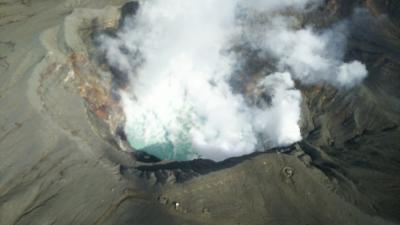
[125,101,199,161]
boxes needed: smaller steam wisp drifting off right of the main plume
[244,16,367,87]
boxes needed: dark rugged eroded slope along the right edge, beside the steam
[304,1,400,221]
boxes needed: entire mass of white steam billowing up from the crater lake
[100,0,367,161]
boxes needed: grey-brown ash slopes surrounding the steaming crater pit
[0,0,400,225]
